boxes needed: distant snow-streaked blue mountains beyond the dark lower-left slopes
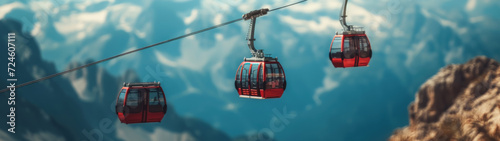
[0,0,500,140]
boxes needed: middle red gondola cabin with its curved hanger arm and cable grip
[234,8,286,99]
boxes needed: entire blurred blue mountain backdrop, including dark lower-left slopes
[0,0,500,140]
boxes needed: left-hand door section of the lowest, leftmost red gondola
[125,88,147,123]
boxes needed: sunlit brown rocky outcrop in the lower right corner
[389,57,500,140]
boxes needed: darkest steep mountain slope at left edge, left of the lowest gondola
[0,20,90,140]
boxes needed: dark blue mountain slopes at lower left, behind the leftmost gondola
[0,19,238,140]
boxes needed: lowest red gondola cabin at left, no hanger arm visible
[115,82,167,124]
